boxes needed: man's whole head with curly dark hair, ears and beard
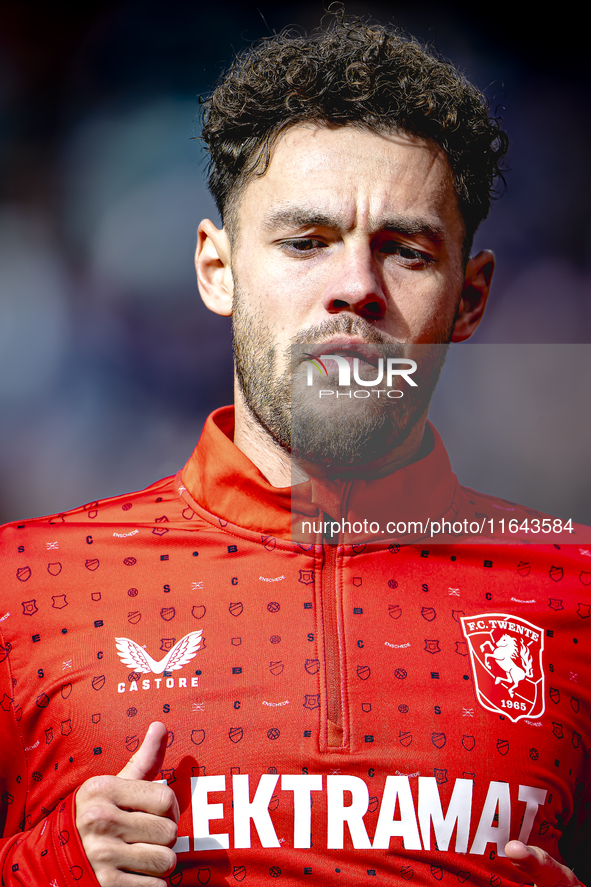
[197,12,507,485]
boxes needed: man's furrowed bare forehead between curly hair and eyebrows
[238,124,457,236]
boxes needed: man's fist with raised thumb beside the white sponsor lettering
[76,721,179,887]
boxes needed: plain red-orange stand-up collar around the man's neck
[182,407,461,542]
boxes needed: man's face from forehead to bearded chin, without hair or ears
[213,124,486,468]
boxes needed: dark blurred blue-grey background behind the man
[0,0,591,524]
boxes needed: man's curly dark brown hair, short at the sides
[202,10,508,257]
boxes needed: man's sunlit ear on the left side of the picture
[195,219,234,317]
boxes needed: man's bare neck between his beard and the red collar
[234,386,428,487]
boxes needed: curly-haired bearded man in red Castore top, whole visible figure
[0,15,591,887]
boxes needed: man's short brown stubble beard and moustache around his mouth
[232,286,455,476]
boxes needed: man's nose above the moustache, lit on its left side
[323,246,387,320]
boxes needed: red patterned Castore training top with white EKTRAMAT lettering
[0,409,591,887]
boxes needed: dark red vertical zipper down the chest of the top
[321,543,349,751]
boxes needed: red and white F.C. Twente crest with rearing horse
[460,613,544,721]
